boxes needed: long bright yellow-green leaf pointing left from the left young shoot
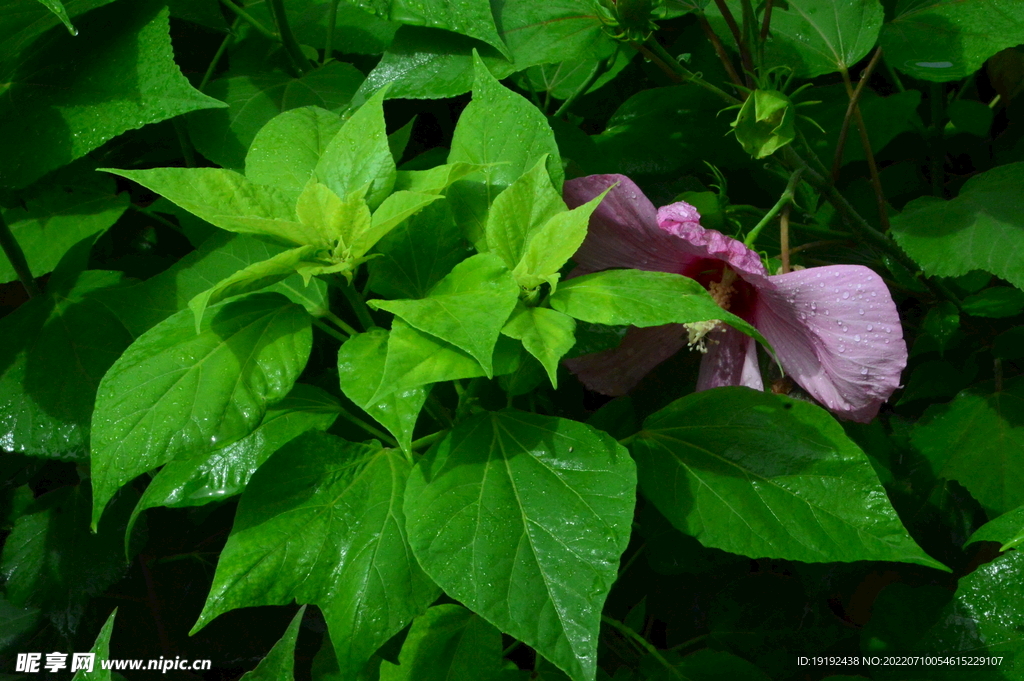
[102,168,317,246]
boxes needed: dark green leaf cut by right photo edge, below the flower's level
[911,379,1024,514]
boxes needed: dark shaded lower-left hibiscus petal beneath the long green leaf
[565,324,686,396]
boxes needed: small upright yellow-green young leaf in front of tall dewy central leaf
[485,154,565,269]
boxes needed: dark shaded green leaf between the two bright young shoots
[368,199,472,298]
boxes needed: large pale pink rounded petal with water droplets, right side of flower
[754,265,907,422]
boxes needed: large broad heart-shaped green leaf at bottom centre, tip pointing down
[406,412,636,681]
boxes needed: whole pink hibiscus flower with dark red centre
[565,175,907,422]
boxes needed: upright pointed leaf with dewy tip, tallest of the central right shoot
[449,56,563,250]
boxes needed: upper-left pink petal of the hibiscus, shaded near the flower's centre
[564,175,692,276]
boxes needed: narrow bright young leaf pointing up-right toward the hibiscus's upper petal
[512,189,608,291]
